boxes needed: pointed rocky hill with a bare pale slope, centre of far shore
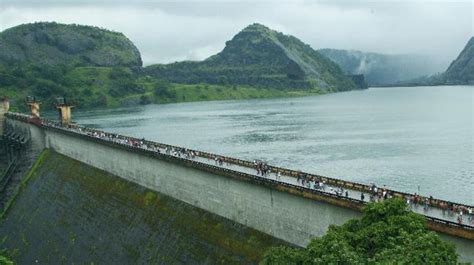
[145,24,358,91]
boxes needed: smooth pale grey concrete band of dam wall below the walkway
[7,117,360,246]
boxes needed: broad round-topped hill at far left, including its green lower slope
[0,22,145,110]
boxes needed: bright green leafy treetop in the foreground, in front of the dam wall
[262,199,457,264]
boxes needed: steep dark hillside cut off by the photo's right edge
[444,37,474,84]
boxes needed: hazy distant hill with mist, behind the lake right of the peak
[318,49,444,85]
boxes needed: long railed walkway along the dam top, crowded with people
[6,113,474,231]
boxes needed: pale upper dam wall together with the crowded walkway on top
[0,100,474,260]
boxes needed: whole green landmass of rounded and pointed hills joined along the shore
[0,22,366,110]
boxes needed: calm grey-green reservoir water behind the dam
[68,86,474,205]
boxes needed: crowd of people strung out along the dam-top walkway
[7,112,474,225]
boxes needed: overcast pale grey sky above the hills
[0,0,474,65]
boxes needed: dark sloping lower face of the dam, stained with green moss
[0,151,286,264]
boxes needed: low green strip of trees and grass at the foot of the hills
[0,57,320,111]
